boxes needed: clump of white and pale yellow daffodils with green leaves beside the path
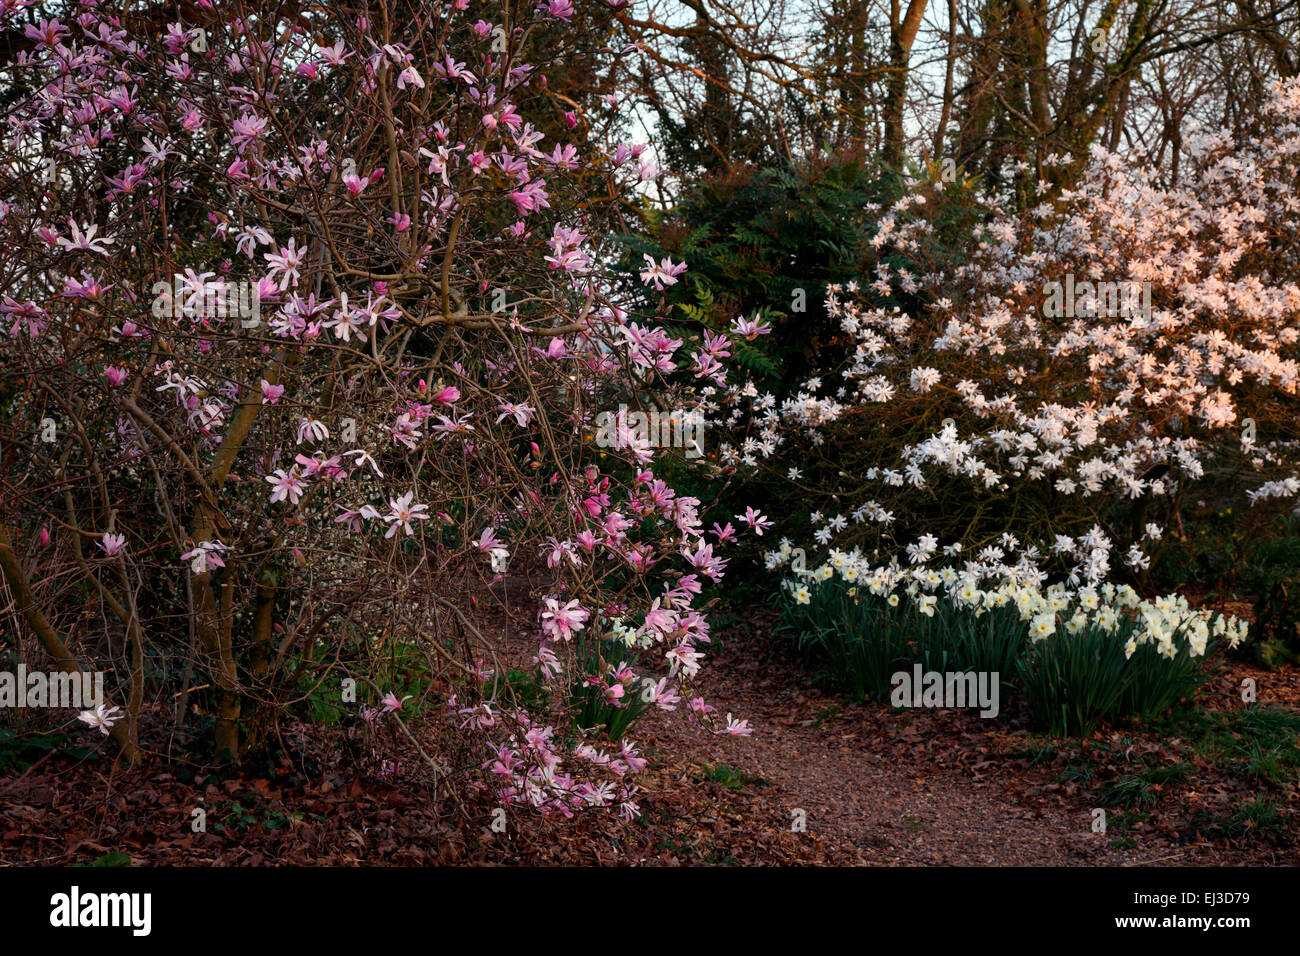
[767,540,1247,734]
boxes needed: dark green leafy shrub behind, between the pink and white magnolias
[621,156,975,393]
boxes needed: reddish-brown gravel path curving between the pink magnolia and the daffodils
[637,645,1131,865]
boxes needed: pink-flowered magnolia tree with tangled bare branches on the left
[0,0,748,814]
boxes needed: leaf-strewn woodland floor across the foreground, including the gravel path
[0,613,1300,866]
